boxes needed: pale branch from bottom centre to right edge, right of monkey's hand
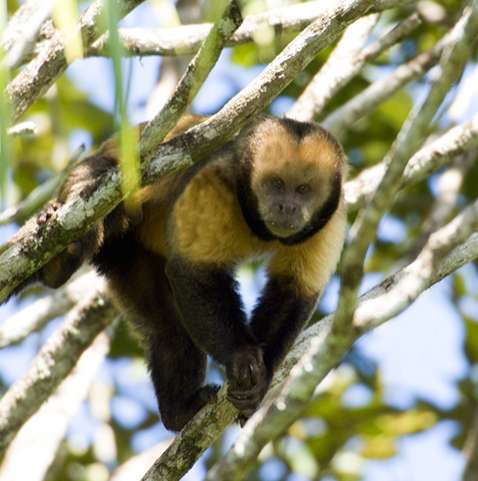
[206,205,478,481]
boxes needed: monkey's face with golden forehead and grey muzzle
[251,123,341,238]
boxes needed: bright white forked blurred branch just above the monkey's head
[287,14,421,121]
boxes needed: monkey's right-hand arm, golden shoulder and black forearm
[251,205,346,377]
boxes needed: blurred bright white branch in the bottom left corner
[0,332,111,481]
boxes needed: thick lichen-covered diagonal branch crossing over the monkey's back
[0,0,401,301]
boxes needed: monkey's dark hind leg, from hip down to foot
[93,233,218,431]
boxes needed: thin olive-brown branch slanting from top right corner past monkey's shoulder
[334,0,478,333]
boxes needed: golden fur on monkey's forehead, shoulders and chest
[134,116,346,296]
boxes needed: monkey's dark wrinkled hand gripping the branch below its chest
[226,345,271,420]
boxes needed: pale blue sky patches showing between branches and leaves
[0,5,477,481]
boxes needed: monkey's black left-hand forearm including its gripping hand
[166,257,268,414]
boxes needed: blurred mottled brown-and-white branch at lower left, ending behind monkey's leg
[0,284,116,454]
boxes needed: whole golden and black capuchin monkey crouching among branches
[26,116,346,431]
